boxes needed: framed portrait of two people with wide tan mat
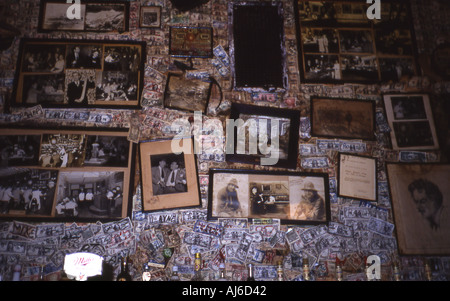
[139,138,202,212]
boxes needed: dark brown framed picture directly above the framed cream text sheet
[310,97,375,140]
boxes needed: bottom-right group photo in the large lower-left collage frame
[55,171,124,218]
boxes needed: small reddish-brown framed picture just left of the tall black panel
[169,26,213,58]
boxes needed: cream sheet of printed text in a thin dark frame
[337,153,378,202]
